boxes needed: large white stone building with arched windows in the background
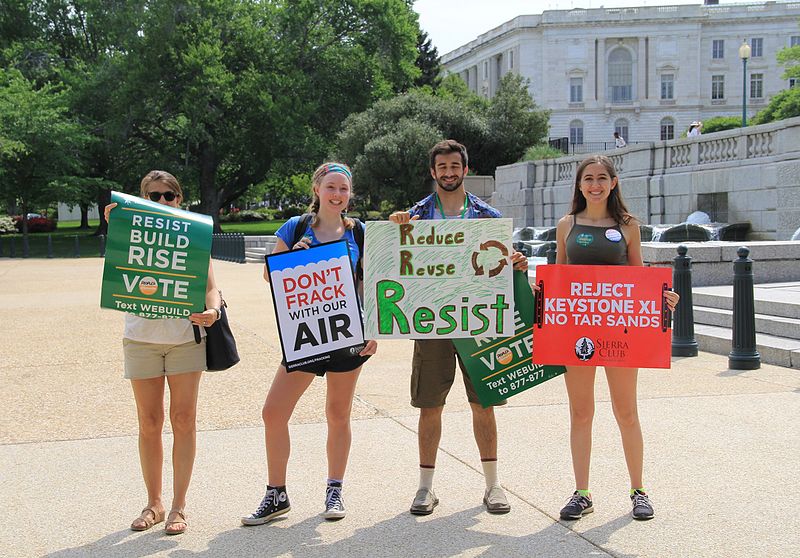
[441,0,800,149]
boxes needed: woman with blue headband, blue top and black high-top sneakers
[242,163,377,525]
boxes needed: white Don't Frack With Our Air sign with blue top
[266,240,364,371]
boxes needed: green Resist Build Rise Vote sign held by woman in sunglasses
[100,192,213,319]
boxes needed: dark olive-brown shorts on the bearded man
[411,339,506,409]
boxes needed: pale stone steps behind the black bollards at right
[692,283,800,369]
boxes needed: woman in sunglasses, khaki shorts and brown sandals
[105,171,221,535]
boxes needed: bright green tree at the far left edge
[0,69,90,235]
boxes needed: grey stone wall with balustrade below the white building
[491,117,800,240]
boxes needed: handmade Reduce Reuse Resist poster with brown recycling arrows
[364,219,514,339]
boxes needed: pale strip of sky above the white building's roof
[414,0,758,55]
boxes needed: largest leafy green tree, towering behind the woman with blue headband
[111,0,417,230]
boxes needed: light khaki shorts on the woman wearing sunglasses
[122,337,206,380]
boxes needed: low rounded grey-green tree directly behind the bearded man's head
[333,76,549,209]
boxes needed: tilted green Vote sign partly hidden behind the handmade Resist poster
[453,272,565,407]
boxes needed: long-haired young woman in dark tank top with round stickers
[556,155,678,520]
